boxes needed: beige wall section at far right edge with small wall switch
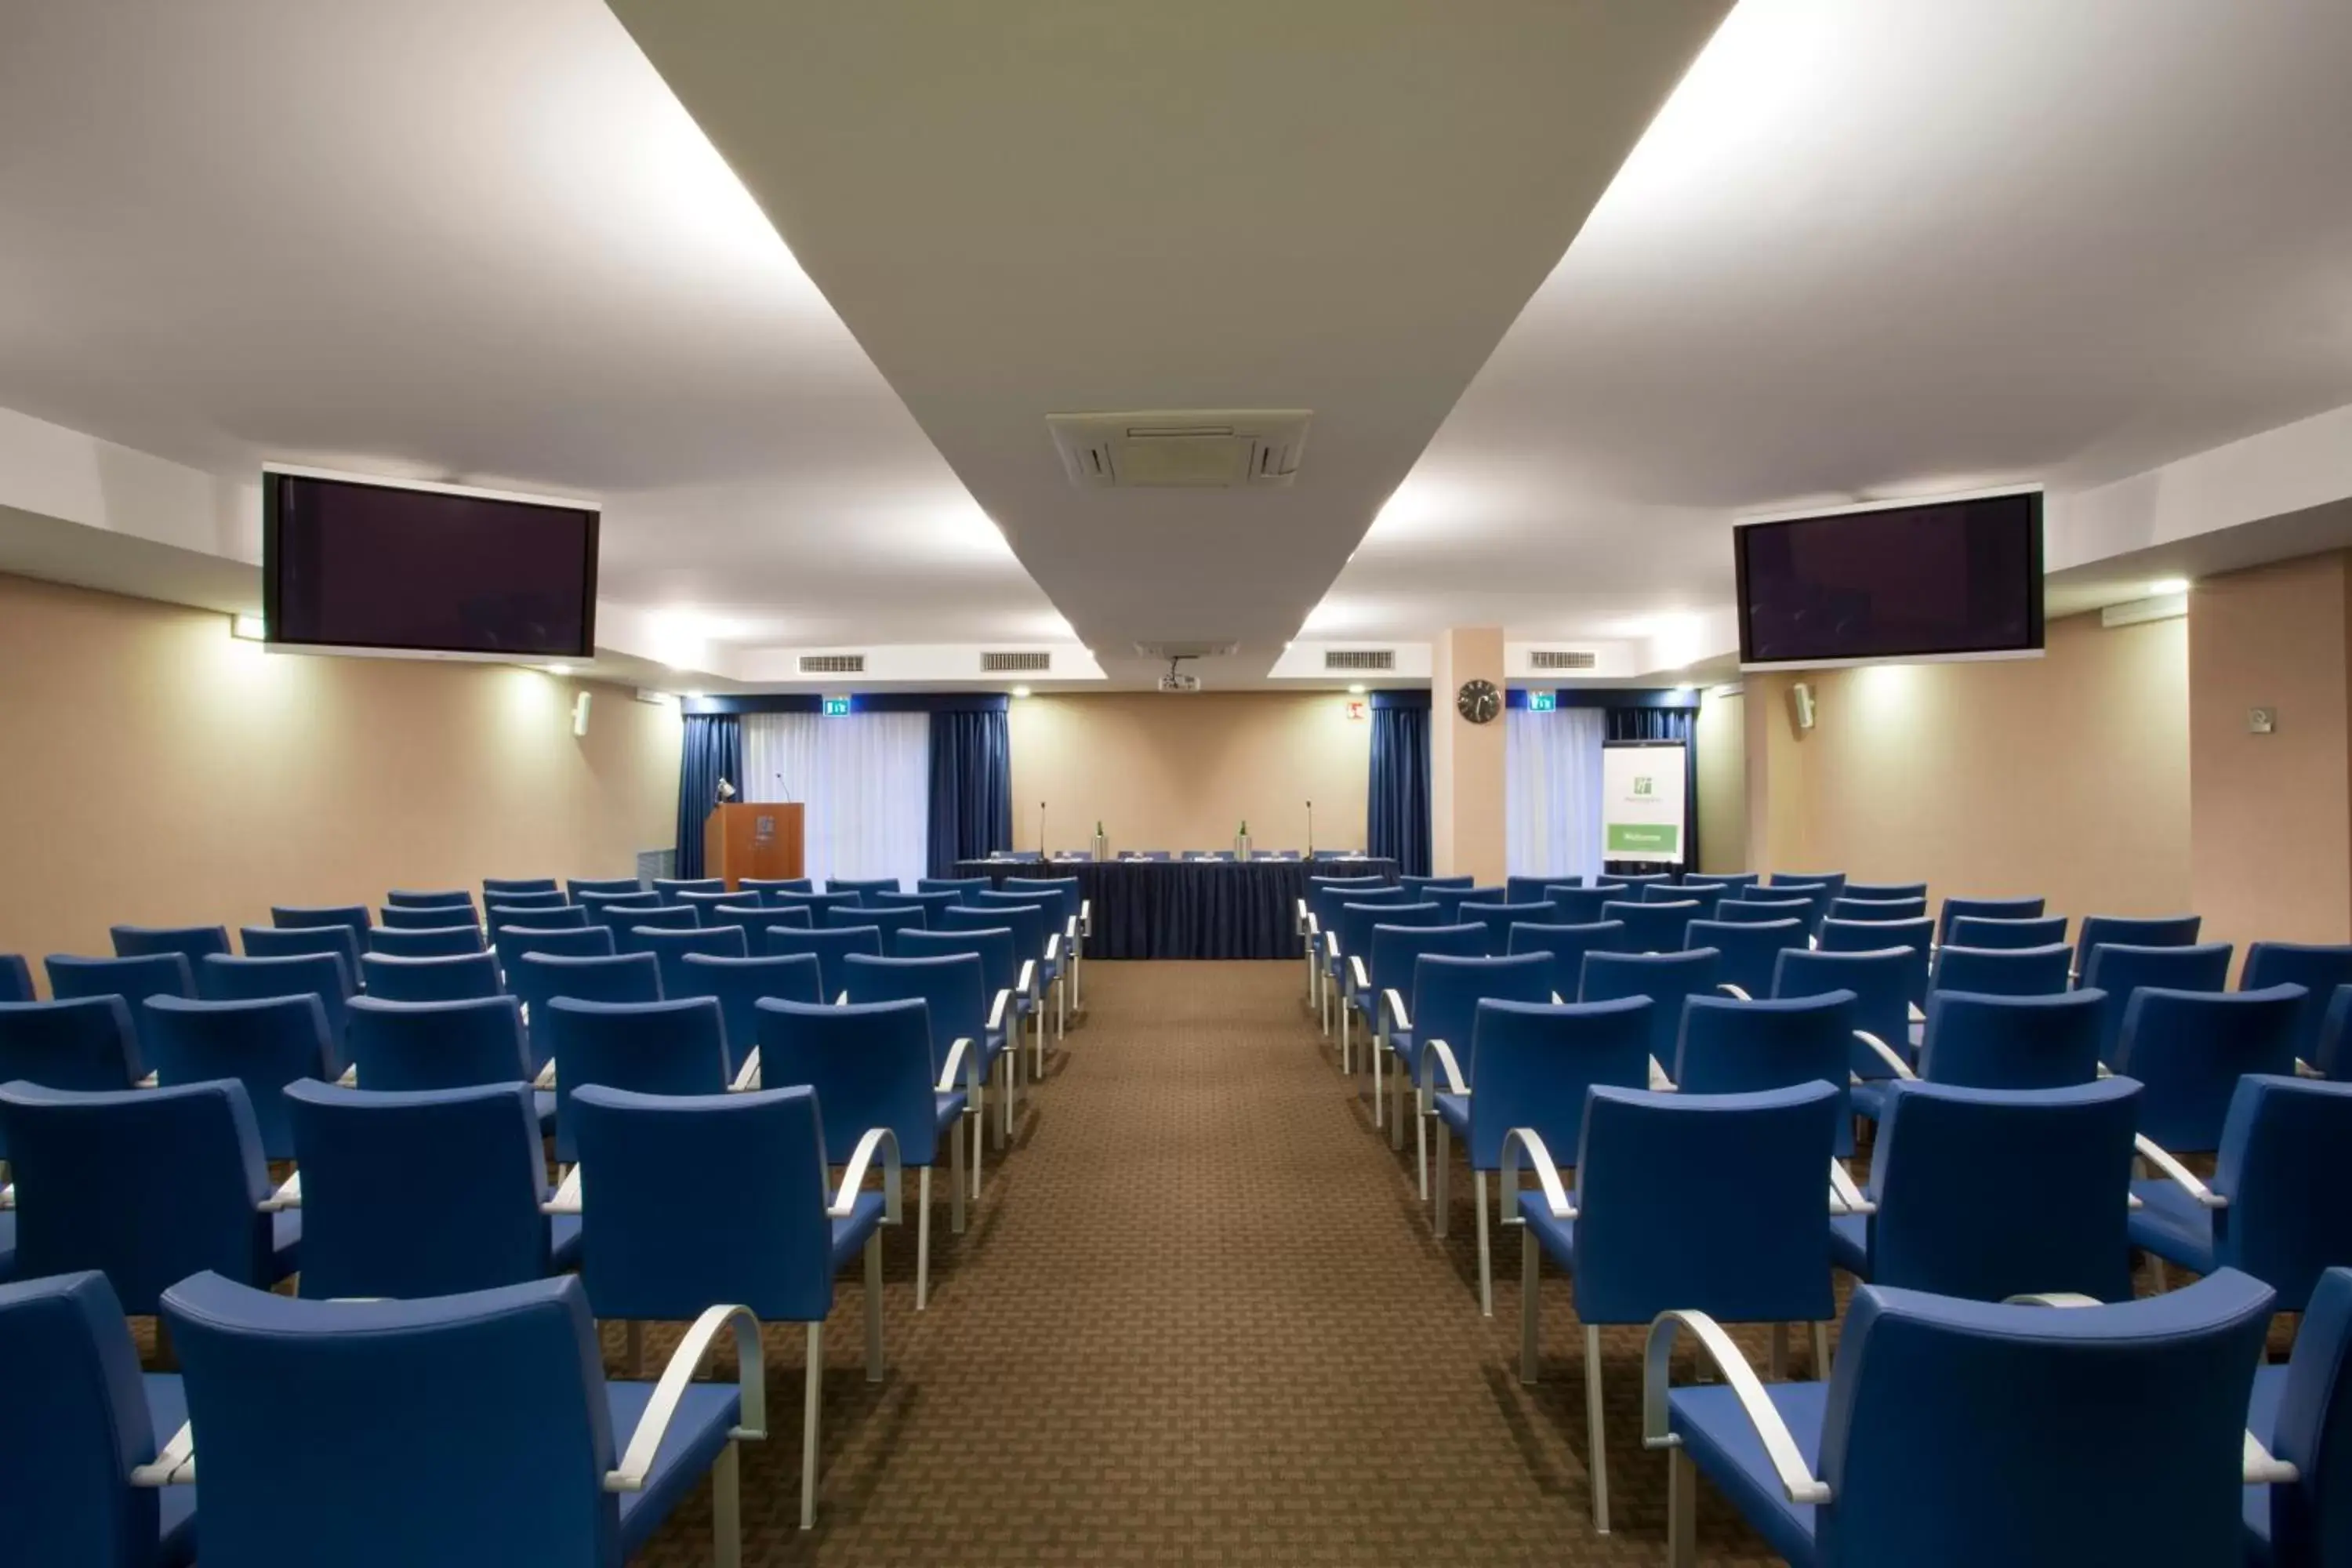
[2190,553,2352,947]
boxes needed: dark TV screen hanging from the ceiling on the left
[261,473,597,659]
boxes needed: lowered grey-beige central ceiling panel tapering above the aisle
[614,0,1729,680]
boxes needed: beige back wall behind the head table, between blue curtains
[1011,691,1371,853]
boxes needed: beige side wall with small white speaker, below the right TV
[1745,611,2192,931]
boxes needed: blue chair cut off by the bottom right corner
[2246,1269,2352,1568]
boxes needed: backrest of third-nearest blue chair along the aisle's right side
[1456,996,1653,1171]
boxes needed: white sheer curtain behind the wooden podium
[743,713,931,888]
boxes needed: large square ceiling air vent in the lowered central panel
[1044,409,1312,489]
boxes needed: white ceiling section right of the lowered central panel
[1310,0,2352,637]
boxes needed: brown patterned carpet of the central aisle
[635,964,1804,1568]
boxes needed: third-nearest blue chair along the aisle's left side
[760,996,976,1312]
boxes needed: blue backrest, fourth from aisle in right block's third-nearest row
[2110,985,2303,1154]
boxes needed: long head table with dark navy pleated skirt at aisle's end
[955,860,1397,959]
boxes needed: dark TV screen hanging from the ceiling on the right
[1733,492,2042,666]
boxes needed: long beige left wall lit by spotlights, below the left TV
[0,576,680,968]
